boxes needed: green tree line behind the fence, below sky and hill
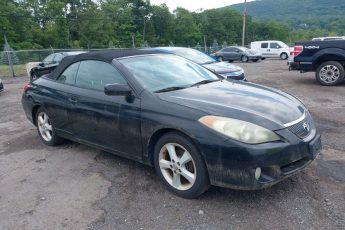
[0,0,326,50]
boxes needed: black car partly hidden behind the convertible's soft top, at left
[30,51,84,82]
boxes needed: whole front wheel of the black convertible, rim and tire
[154,132,210,199]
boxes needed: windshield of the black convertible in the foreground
[119,54,220,92]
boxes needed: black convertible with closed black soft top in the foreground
[22,50,321,198]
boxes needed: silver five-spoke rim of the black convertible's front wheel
[159,143,196,191]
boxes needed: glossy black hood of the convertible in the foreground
[158,81,306,130]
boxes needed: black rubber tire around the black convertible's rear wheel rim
[35,107,64,146]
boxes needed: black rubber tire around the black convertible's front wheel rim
[153,132,210,199]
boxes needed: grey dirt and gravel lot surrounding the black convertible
[0,60,345,230]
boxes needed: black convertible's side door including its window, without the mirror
[69,60,142,159]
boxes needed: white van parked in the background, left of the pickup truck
[250,41,290,60]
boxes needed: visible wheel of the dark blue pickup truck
[316,61,344,86]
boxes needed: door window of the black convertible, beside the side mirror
[76,60,127,91]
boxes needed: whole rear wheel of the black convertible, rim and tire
[36,108,63,146]
